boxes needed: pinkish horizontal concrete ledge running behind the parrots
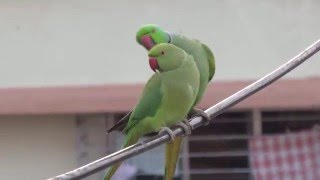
[0,78,320,115]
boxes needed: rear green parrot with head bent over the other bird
[136,24,215,180]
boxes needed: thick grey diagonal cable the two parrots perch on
[49,39,320,180]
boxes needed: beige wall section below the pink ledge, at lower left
[0,116,77,180]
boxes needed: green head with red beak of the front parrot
[148,43,186,72]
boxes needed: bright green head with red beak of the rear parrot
[136,24,170,50]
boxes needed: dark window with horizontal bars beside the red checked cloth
[108,110,320,180]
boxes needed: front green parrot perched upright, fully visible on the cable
[104,43,200,180]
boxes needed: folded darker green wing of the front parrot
[123,74,163,133]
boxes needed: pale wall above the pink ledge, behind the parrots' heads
[0,0,320,87]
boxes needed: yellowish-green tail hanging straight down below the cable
[164,137,183,180]
